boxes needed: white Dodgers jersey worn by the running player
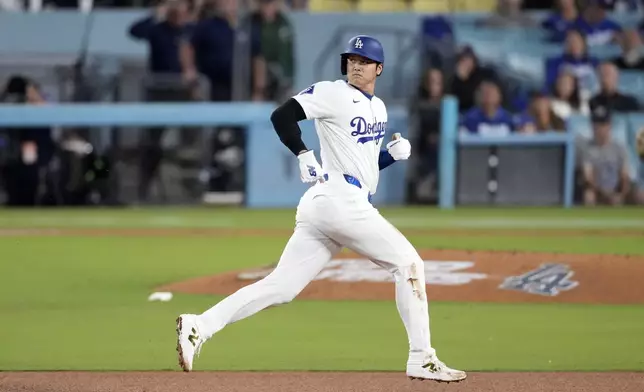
[293,80,387,194]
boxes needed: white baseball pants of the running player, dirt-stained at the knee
[199,174,435,362]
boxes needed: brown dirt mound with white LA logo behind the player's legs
[157,250,644,304]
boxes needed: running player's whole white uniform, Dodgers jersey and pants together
[196,80,435,370]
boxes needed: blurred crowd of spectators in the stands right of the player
[415,0,644,205]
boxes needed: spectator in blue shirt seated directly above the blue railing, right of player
[460,81,515,136]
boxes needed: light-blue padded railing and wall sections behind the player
[0,97,644,208]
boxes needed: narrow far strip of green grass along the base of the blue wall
[0,207,644,230]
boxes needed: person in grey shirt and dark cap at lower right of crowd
[579,106,631,205]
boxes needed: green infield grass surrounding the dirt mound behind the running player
[0,209,644,371]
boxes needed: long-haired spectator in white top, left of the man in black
[550,71,590,120]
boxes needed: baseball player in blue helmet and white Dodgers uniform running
[177,35,466,382]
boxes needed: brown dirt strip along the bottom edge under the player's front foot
[0,372,644,392]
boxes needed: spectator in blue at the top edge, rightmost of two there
[573,0,622,46]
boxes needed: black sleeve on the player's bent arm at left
[271,98,308,155]
